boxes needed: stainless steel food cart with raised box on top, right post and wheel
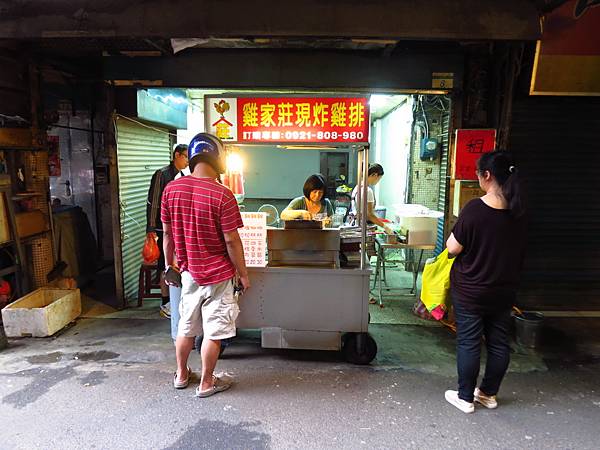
[237,146,377,364]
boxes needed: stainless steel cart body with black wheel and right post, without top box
[237,147,377,364]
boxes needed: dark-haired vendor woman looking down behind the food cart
[281,173,333,222]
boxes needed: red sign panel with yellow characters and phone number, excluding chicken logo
[237,97,369,143]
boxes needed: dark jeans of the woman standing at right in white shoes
[454,301,511,402]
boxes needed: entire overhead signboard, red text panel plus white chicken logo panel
[206,97,369,144]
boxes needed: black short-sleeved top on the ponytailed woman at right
[450,199,526,312]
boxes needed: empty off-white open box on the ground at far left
[2,287,81,337]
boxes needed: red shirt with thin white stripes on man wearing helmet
[161,176,244,286]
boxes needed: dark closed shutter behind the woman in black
[510,97,600,310]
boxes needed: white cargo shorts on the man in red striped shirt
[177,271,240,341]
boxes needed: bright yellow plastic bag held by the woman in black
[421,249,454,320]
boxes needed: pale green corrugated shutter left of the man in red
[117,117,170,300]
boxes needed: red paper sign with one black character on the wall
[452,129,496,180]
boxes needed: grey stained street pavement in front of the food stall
[0,312,600,449]
